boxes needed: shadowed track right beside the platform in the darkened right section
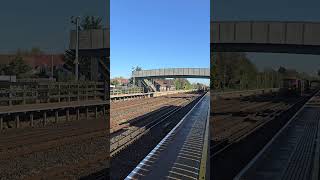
[210,91,316,180]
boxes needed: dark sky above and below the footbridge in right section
[210,0,320,73]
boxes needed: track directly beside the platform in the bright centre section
[111,94,203,179]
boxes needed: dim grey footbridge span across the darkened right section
[210,21,320,55]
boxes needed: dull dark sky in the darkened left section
[0,0,109,53]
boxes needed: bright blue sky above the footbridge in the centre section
[110,0,210,84]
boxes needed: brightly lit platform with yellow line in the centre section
[126,93,210,180]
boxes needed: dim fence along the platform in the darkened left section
[0,82,107,106]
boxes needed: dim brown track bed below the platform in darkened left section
[0,112,109,179]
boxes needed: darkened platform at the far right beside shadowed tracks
[234,92,320,180]
